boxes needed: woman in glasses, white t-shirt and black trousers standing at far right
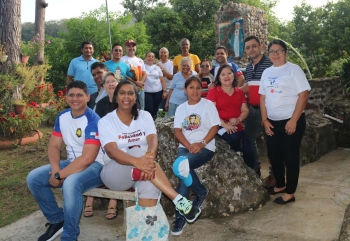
[259,39,311,204]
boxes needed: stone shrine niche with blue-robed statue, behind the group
[215,2,268,63]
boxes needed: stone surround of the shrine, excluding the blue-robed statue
[215,1,268,63]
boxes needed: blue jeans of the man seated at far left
[27,160,103,241]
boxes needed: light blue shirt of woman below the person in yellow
[169,70,197,105]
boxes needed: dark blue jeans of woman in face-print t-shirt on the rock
[176,147,214,218]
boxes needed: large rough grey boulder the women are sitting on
[156,118,269,217]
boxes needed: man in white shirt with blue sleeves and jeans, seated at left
[27,81,103,241]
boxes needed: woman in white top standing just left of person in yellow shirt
[157,47,174,110]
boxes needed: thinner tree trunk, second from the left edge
[34,0,48,64]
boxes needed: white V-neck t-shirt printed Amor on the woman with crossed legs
[98,110,157,152]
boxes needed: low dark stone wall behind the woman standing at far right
[258,77,350,165]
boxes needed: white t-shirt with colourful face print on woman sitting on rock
[174,99,220,151]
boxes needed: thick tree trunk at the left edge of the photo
[0,0,22,73]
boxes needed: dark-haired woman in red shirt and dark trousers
[207,64,254,169]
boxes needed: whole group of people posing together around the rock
[27,36,310,240]
